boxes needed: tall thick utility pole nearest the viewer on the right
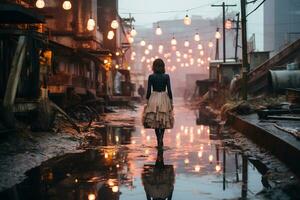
[241,0,249,100]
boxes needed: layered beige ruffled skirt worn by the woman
[142,92,174,129]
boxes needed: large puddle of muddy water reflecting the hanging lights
[0,101,263,200]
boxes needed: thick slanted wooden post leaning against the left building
[3,36,26,108]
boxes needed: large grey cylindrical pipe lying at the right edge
[268,70,300,92]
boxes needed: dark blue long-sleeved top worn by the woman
[146,73,173,100]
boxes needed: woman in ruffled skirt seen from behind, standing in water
[143,58,174,147]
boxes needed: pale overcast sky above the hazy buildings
[119,0,263,49]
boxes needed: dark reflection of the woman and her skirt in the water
[142,149,175,200]
